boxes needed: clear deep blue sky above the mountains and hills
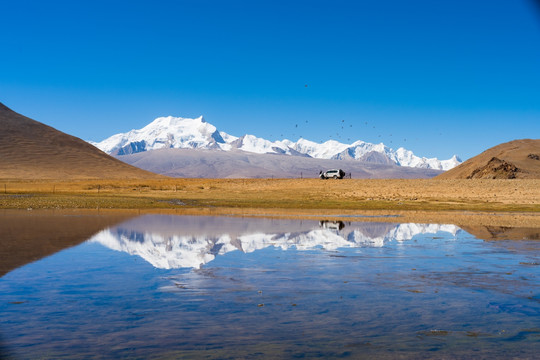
[0,0,540,160]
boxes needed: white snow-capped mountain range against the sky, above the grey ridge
[90,116,461,170]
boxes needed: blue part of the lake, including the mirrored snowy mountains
[0,215,540,359]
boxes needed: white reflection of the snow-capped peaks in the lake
[89,218,460,269]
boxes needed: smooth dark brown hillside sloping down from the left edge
[0,103,158,179]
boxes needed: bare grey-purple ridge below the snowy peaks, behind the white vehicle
[119,149,442,179]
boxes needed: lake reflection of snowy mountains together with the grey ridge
[91,215,459,269]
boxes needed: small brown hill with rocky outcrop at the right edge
[437,139,540,179]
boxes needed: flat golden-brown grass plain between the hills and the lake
[0,179,540,226]
